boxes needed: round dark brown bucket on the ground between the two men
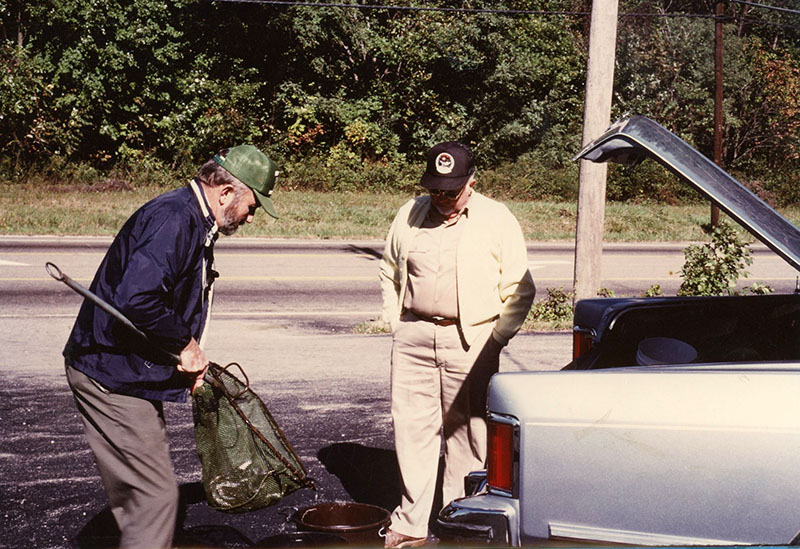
[293,502,390,545]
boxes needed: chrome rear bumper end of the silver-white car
[436,494,520,546]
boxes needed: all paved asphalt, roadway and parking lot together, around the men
[0,237,794,548]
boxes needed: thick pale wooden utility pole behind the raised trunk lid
[574,0,618,301]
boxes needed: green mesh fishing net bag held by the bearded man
[192,363,314,513]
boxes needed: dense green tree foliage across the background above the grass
[0,0,800,201]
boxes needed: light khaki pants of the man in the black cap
[391,313,499,537]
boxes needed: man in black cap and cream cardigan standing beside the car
[380,141,536,547]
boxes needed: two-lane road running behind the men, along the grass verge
[0,236,798,321]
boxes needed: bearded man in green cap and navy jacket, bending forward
[63,145,277,548]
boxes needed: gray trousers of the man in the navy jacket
[67,366,178,548]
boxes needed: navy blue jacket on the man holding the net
[64,183,216,402]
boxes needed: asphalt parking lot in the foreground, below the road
[0,310,570,548]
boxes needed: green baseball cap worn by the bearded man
[214,145,278,219]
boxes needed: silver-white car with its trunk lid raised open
[438,117,800,546]
